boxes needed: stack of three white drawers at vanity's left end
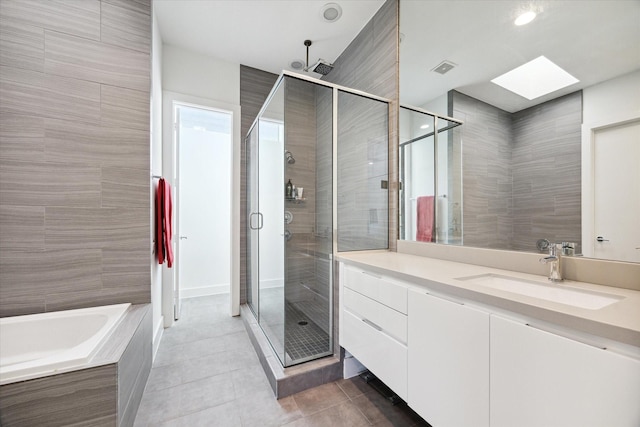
[340,265,408,400]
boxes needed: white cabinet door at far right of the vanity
[490,315,640,427]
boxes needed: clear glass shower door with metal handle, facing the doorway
[245,81,285,360]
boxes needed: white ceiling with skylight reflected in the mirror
[400,0,640,112]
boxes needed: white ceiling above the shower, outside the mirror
[153,0,384,77]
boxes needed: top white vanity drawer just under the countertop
[344,266,407,314]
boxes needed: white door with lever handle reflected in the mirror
[587,121,640,262]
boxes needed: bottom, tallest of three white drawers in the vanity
[340,310,408,400]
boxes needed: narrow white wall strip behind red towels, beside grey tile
[149,6,163,357]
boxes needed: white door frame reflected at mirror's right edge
[582,112,640,258]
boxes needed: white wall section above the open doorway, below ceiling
[162,45,240,105]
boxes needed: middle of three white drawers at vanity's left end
[342,288,407,344]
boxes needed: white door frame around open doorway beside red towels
[162,90,241,328]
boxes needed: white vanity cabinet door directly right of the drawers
[407,290,489,427]
